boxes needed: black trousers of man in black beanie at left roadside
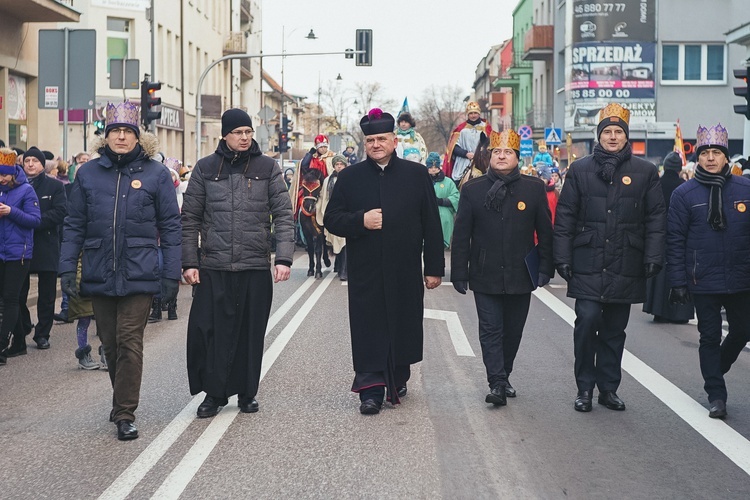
[13,271,57,345]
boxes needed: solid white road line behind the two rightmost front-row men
[533,288,750,474]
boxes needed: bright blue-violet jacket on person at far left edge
[0,166,42,262]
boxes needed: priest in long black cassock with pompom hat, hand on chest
[323,108,445,415]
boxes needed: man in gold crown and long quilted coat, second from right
[554,103,665,412]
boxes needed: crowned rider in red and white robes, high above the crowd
[443,101,492,185]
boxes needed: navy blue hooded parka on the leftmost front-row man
[59,148,182,297]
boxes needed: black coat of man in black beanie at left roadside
[30,174,68,273]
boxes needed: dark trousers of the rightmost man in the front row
[693,292,750,402]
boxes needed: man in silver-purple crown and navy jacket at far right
[667,124,750,418]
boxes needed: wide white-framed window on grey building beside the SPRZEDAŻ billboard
[661,43,726,85]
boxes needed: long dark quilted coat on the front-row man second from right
[554,155,666,304]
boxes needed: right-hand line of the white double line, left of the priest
[151,272,334,500]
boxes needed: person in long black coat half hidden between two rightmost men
[643,151,695,324]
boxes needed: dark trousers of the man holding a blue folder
[474,292,531,389]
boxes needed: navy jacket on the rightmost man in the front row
[667,175,750,294]
